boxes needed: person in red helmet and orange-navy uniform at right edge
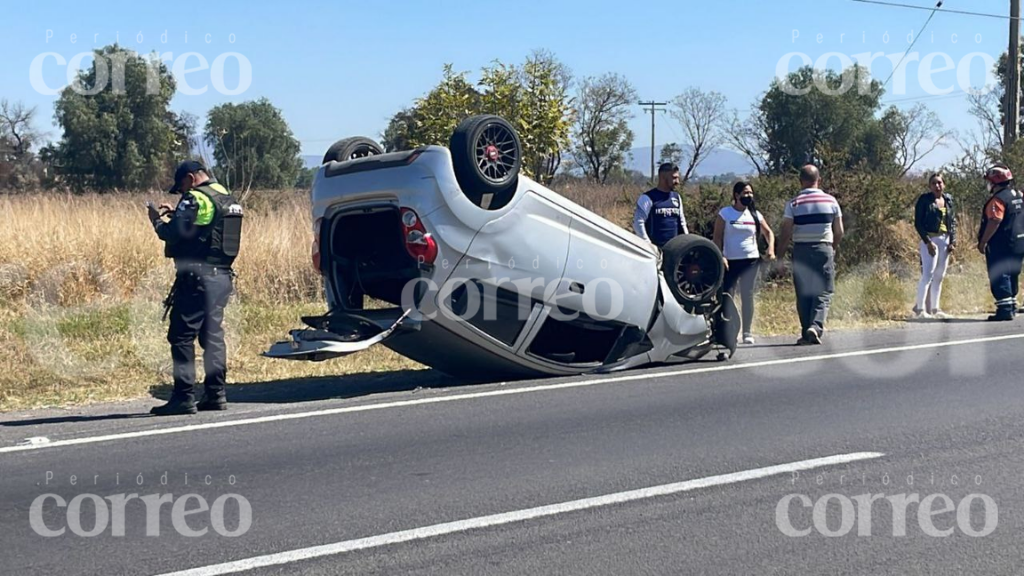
[978,164,1024,322]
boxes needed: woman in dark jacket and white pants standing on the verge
[913,174,956,319]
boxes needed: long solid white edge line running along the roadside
[0,334,1024,454]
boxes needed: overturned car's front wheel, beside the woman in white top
[662,235,725,313]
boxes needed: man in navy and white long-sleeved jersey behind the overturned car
[633,163,689,248]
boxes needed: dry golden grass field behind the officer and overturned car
[0,187,990,411]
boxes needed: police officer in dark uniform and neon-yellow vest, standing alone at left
[148,160,242,416]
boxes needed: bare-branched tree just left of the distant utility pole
[572,74,637,182]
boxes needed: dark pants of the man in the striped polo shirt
[793,242,836,334]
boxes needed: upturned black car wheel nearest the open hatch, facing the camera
[449,115,522,210]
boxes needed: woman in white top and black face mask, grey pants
[715,181,775,344]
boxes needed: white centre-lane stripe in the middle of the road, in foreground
[160,452,885,576]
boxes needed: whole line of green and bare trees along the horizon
[8,44,1024,193]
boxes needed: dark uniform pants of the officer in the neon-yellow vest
[167,270,231,400]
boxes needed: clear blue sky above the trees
[0,0,1009,165]
